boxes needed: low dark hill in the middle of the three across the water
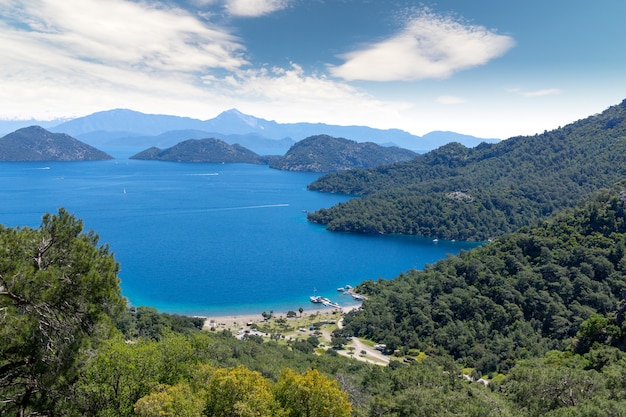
[130,138,267,164]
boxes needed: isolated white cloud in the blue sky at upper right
[329,11,514,81]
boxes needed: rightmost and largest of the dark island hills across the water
[270,135,417,172]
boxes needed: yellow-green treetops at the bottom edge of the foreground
[134,364,352,417]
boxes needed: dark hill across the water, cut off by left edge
[0,126,113,161]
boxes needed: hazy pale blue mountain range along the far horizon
[0,109,500,155]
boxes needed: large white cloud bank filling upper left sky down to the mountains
[0,0,408,127]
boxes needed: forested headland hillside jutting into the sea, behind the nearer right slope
[308,100,626,241]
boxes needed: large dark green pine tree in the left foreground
[0,209,125,416]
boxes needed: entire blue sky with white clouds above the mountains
[0,0,626,139]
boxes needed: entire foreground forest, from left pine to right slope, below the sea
[0,184,626,417]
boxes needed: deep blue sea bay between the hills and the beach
[0,153,477,316]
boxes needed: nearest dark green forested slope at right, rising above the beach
[344,184,626,374]
